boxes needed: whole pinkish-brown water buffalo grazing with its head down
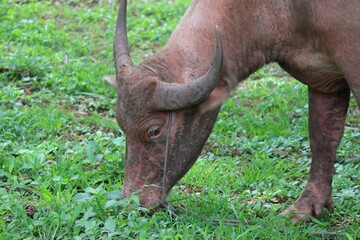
[114,0,360,221]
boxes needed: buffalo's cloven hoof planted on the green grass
[281,187,334,224]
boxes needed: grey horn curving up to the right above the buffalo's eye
[155,28,223,111]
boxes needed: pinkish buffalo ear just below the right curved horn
[198,81,230,114]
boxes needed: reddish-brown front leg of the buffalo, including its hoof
[282,88,350,223]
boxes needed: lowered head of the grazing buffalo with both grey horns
[114,1,223,207]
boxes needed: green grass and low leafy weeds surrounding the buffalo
[0,0,360,239]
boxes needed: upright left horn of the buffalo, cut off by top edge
[114,0,133,72]
